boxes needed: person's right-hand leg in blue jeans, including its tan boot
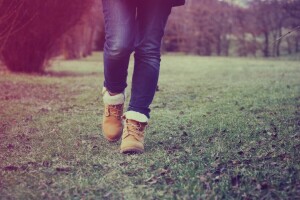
[121,0,171,153]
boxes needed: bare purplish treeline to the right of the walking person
[164,0,300,57]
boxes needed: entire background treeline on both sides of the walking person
[0,0,300,72]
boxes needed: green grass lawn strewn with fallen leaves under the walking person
[0,54,300,199]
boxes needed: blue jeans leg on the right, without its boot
[128,0,171,118]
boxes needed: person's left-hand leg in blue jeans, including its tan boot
[102,0,136,141]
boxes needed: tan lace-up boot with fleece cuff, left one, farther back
[102,89,125,142]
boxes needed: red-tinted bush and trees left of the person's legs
[0,0,103,73]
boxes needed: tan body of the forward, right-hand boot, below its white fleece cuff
[120,112,148,153]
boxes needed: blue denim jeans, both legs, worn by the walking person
[102,0,172,118]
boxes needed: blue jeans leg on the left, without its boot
[102,0,136,93]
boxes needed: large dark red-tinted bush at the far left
[0,0,92,72]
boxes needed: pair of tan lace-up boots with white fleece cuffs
[102,88,148,153]
